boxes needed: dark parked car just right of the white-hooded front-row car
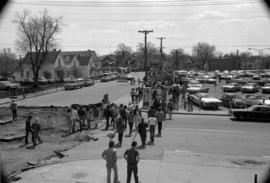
[220,93,246,108]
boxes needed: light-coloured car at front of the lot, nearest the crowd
[190,93,222,109]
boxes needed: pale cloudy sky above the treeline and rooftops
[0,0,270,55]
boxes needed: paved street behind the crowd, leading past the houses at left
[7,72,144,106]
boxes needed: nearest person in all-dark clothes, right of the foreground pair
[124,141,140,183]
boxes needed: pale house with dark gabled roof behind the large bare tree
[14,50,97,81]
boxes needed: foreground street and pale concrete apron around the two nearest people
[15,115,270,183]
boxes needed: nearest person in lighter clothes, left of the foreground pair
[101,141,120,183]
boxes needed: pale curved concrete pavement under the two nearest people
[14,151,264,183]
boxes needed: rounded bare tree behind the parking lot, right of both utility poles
[192,42,216,70]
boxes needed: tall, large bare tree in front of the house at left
[14,9,63,87]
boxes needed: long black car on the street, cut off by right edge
[231,105,270,121]
